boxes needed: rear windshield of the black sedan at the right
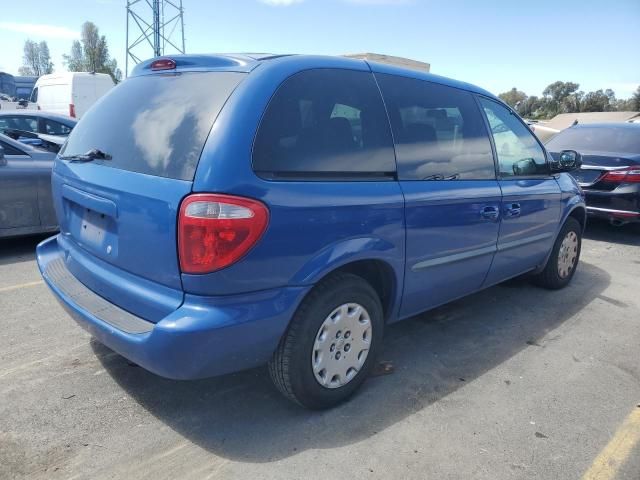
[546,127,640,154]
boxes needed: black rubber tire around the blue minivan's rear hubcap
[269,273,384,409]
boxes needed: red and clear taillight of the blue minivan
[178,194,269,273]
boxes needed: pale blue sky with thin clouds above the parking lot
[0,0,640,98]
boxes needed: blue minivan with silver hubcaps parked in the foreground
[37,55,586,408]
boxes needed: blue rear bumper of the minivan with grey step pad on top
[37,237,310,380]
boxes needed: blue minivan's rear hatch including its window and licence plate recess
[53,71,245,321]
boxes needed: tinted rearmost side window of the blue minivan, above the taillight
[253,69,395,179]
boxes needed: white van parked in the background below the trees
[31,72,114,119]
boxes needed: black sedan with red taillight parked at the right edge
[547,123,640,226]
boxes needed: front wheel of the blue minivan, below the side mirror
[534,217,582,290]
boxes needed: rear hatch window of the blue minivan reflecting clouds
[60,72,246,180]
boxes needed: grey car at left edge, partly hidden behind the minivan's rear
[0,133,58,238]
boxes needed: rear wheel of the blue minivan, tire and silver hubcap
[269,273,384,409]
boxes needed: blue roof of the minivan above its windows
[130,53,503,103]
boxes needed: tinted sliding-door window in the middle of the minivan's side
[376,74,495,180]
